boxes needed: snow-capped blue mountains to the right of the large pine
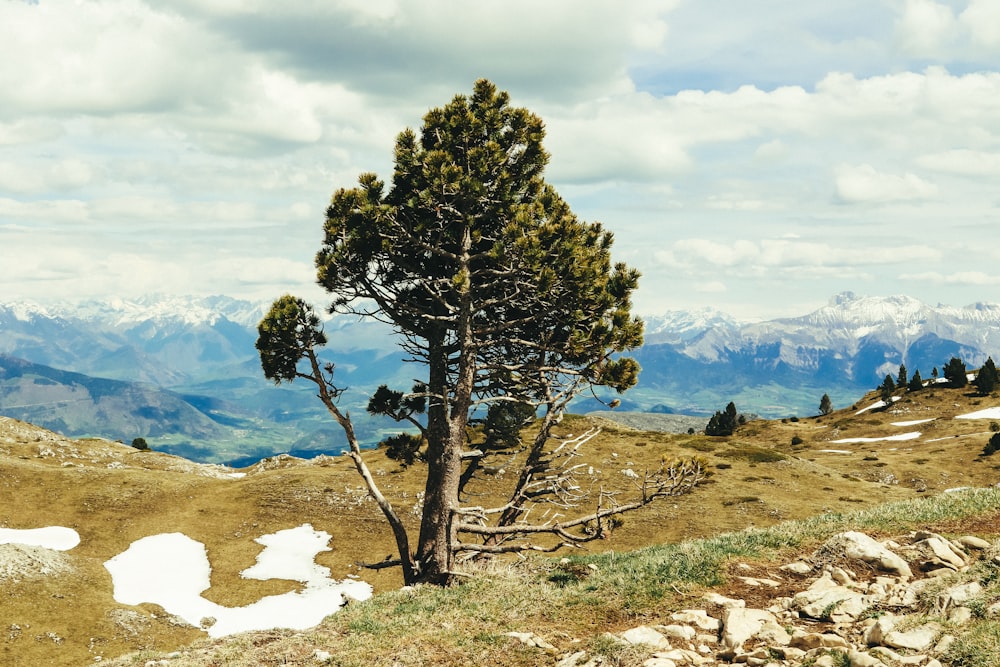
[636,292,1000,416]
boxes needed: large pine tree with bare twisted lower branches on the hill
[257,80,702,584]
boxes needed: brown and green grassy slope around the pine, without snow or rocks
[0,389,1000,665]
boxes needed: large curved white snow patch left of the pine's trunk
[104,524,372,638]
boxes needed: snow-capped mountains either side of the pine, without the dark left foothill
[0,293,1000,454]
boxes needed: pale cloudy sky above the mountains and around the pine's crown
[0,0,1000,319]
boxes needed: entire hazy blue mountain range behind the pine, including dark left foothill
[0,293,1000,462]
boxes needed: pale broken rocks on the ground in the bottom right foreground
[524,531,1000,667]
